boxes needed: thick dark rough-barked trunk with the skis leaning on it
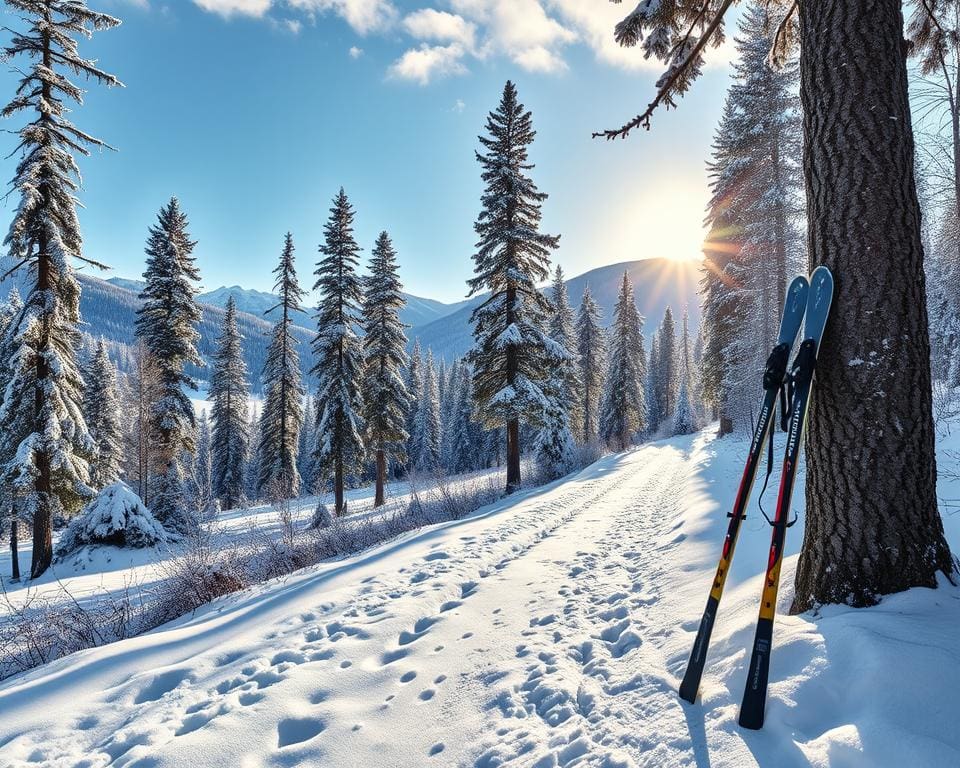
[793,0,952,611]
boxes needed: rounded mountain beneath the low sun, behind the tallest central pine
[408,259,700,362]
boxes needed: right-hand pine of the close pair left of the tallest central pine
[363,232,410,507]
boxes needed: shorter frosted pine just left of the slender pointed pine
[210,296,250,509]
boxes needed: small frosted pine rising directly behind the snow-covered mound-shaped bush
[83,339,123,491]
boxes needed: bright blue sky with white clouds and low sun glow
[0,0,728,301]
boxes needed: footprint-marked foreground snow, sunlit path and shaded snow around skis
[0,433,960,768]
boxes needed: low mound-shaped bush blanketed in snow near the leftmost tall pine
[58,481,167,557]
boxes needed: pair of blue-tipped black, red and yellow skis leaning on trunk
[680,267,833,729]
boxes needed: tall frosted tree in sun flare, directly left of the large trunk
[701,4,806,432]
